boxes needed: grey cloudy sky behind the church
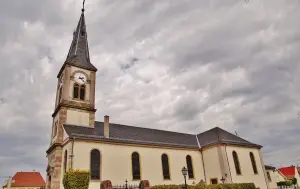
[0,0,300,183]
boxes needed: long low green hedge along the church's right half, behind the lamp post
[151,183,256,189]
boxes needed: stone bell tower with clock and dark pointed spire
[46,3,97,189]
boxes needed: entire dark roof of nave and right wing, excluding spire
[64,122,261,149]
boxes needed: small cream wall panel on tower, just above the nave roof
[66,109,90,126]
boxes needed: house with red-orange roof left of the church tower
[3,171,46,189]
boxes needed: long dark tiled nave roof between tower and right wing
[64,122,198,148]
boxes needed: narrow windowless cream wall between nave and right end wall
[202,147,222,184]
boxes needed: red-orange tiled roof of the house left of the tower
[4,172,46,187]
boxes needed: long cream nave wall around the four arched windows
[73,141,205,189]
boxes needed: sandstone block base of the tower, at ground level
[46,145,63,189]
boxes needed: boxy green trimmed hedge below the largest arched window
[63,170,90,189]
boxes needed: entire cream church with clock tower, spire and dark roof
[46,5,269,189]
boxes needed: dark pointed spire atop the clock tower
[66,0,97,71]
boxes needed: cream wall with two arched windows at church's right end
[227,146,268,189]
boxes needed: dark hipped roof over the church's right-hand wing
[197,127,261,147]
